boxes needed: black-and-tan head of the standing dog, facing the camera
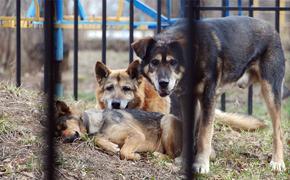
[132,37,184,97]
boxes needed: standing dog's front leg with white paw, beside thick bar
[193,82,216,173]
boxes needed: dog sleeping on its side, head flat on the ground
[56,101,182,160]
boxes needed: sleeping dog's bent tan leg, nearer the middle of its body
[120,132,145,160]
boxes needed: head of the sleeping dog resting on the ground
[55,101,84,143]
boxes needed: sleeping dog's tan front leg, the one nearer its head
[94,134,120,154]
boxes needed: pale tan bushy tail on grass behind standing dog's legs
[215,109,267,131]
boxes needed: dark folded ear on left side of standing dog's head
[131,37,155,59]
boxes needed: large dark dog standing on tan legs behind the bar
[132,17,285,173]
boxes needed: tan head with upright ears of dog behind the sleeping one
[95,60,142,109]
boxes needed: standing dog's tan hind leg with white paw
[261,80,285,171]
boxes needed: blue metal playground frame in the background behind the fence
[26,0,242,98]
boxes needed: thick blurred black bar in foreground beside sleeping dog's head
[43,1,56,179]
